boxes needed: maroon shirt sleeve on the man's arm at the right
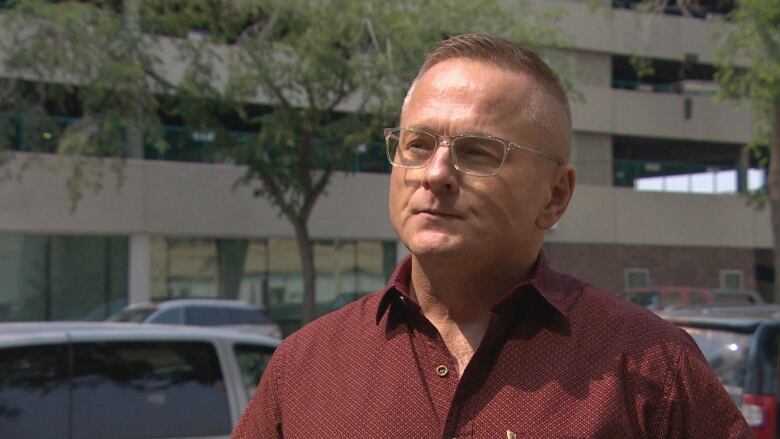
[660,340,754,439]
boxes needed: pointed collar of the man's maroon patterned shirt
[376,250,582,324]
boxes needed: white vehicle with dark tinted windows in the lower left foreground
[0,322,280,439]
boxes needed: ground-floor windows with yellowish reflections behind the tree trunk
[152,237,396,319]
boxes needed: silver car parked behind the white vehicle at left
[108,299,282,338]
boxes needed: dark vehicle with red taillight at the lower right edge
[659,305,780,439]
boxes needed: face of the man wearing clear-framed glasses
[390,59,568,259]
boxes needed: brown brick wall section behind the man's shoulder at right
[544,243,756,291]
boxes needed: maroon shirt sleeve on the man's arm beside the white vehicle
[231,346,284,439]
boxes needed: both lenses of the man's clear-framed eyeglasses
[387,129,504,175]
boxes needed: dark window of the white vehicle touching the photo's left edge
[0,345,68,438]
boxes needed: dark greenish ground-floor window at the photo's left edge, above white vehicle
[0,233,128,321]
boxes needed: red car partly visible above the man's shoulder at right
[620,286,764,311]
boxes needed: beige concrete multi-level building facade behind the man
[0,0,773,326]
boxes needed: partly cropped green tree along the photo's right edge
[716,0,780,303]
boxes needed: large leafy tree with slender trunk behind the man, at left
[0,0,559,322]
